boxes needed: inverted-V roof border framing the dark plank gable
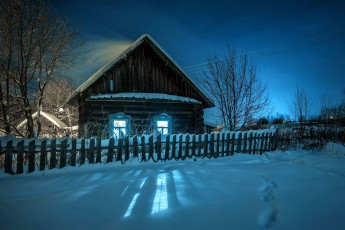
[67,34,214,107]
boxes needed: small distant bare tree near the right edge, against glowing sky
[290,85,313,122]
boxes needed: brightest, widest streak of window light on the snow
[151,173,168,214]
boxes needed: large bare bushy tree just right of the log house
[200,45,270,130]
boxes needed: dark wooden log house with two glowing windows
[68,35,214,138]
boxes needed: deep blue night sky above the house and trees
[53,0,345,118]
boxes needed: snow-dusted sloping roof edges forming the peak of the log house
[67,34,214,106]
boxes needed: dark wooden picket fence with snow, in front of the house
[0,130,276,174]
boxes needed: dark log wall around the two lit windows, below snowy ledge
[79,99,204,138]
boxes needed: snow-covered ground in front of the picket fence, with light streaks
[0,143,345,230]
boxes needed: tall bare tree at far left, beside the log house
[0,0,77,137]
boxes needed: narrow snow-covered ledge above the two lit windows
[90,93,200,103]
